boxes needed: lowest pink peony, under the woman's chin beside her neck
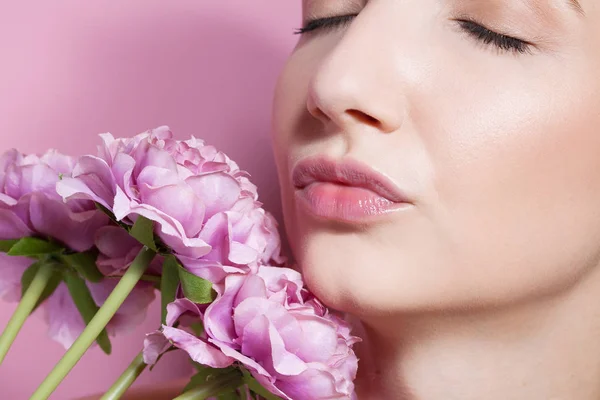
[144,266,360,400]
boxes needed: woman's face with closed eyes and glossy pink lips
[273,0,600,316]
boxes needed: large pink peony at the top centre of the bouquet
[58,127,283,281]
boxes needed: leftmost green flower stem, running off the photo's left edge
[0,263,53,364]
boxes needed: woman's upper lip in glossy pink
[292,157,410,203]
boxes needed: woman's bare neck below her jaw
[356,268,600,400]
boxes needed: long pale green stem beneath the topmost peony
[29,247,156,400]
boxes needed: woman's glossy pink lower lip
[296,182,410,222]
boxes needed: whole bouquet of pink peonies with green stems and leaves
[0,127,359,400]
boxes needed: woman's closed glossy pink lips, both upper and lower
[292,157,412,222]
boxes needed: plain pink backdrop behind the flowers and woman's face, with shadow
[0,0,300,400]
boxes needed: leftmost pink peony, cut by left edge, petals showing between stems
[0,150,155,348]
